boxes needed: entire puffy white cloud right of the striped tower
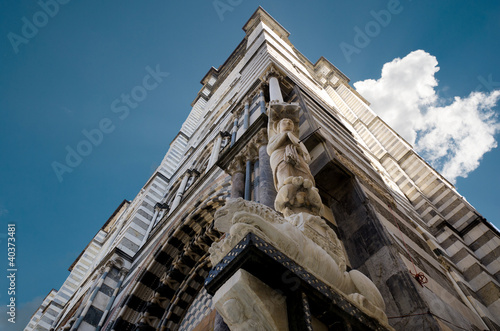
[354,50,500,183]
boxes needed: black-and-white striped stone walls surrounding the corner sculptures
[25,7,500,331]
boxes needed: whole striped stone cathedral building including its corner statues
[25,8,500,331]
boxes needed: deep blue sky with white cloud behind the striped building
[0,0,500,330]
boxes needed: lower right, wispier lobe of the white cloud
[417,90,500,182]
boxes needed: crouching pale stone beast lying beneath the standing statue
[207,199,390,329]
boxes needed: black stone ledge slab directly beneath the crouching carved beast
[205,233,388,330]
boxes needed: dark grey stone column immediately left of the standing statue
[256,130,276,209]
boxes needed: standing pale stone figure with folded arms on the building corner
[267,102,322,216]
